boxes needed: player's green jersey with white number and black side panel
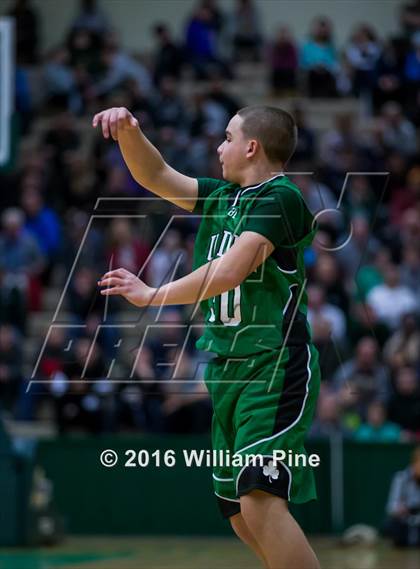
[193,174,316,358]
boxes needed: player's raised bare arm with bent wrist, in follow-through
[92,107,198,211]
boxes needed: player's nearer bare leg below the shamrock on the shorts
[241,490,320,569]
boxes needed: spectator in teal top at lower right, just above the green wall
[354,401,401,443]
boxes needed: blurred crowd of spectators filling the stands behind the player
[0,0,420,441]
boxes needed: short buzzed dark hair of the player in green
[237,105,297,164]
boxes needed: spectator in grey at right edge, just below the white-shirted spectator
[383,313,420,369]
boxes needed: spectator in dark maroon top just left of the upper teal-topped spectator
[268,26,300,93]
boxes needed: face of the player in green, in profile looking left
[217,115,249,183]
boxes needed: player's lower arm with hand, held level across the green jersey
[98,231,274,306]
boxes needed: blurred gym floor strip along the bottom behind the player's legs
[0,537,420,569]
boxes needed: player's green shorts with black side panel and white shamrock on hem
[205,344,320,517]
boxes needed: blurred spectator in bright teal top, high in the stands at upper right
[300,18,338,97]
